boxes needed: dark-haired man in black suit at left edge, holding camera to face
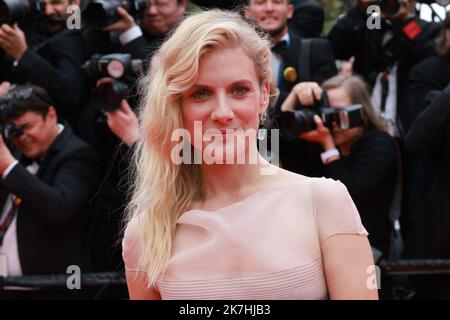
[0,86,99,276]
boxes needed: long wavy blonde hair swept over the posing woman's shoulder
[125,10,271,286]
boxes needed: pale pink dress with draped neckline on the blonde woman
[123,176,368,300]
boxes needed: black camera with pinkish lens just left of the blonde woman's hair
[82,53,143,112]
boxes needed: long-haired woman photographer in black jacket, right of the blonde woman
[281,75,397,257]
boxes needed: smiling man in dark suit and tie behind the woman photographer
[244,0,336,176]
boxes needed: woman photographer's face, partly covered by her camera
[327,88,362,146]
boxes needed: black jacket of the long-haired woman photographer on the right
[317,130,398,257]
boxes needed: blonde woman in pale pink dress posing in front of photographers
[123,10,377,299]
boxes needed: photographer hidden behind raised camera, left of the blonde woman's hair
[78,60,142,271]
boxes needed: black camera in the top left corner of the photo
[0,0,44,24]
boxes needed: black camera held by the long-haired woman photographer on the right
[279,92,365,140]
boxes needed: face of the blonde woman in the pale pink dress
[182,48,269,162]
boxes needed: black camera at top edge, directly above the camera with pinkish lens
[82,0,148,29]
